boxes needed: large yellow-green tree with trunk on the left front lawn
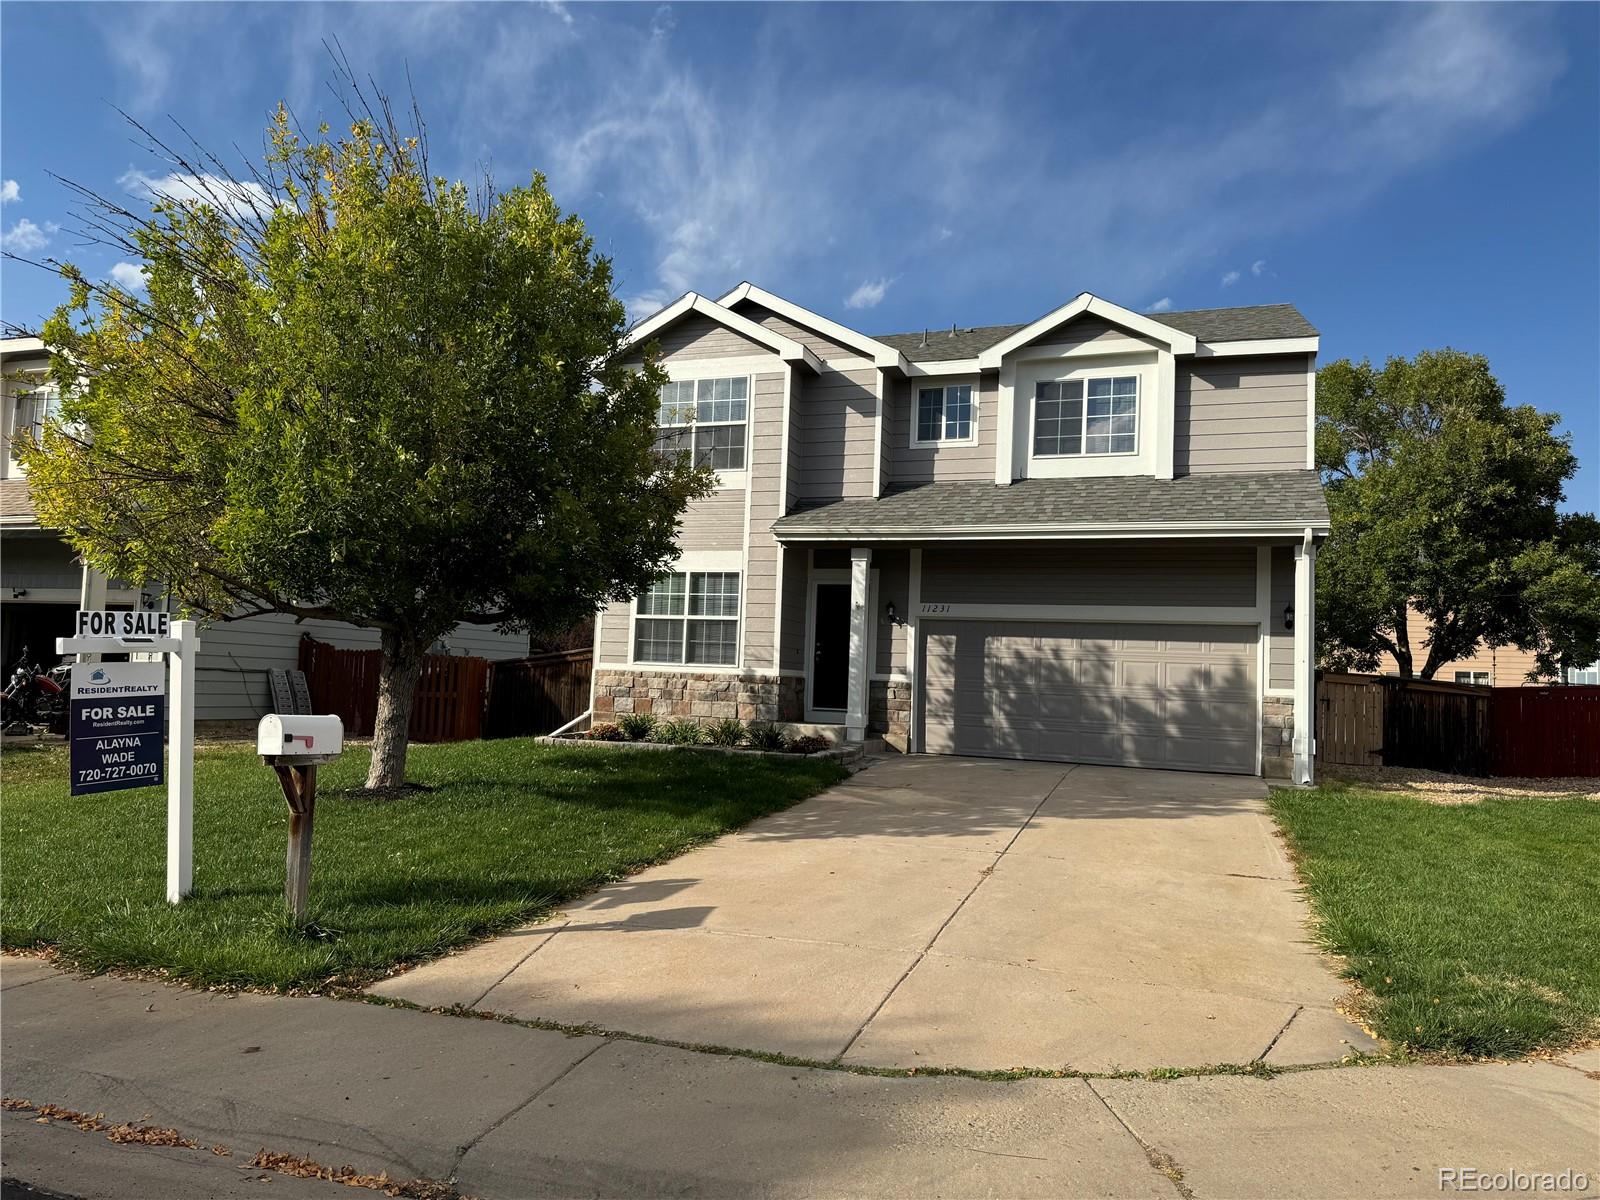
[24,93,709,787]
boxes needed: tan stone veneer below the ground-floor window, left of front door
[594,667,805,723]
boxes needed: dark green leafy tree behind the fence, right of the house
[1317,349,1600,678]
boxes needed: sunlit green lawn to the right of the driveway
[1270,784,1600,1056]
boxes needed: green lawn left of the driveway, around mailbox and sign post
[0,739,845,989]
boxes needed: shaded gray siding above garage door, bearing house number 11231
[922,542,1256,608]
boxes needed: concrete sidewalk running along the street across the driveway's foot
[0,958,1600,1200]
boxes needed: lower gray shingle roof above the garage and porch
[773,470,1328,539]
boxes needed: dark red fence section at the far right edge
[1490,686,1600,779]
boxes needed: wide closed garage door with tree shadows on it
[922,621,1259,774]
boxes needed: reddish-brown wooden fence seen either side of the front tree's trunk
[299,634,490,742]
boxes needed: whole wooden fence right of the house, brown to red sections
[1317,672,1600,779]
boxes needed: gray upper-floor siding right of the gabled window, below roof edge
[1173,355,1309,475]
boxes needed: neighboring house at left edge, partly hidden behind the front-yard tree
[0,338,528,722]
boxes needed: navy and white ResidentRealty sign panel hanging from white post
[70,662,166,795]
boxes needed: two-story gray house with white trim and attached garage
[594,283,1328,781]
